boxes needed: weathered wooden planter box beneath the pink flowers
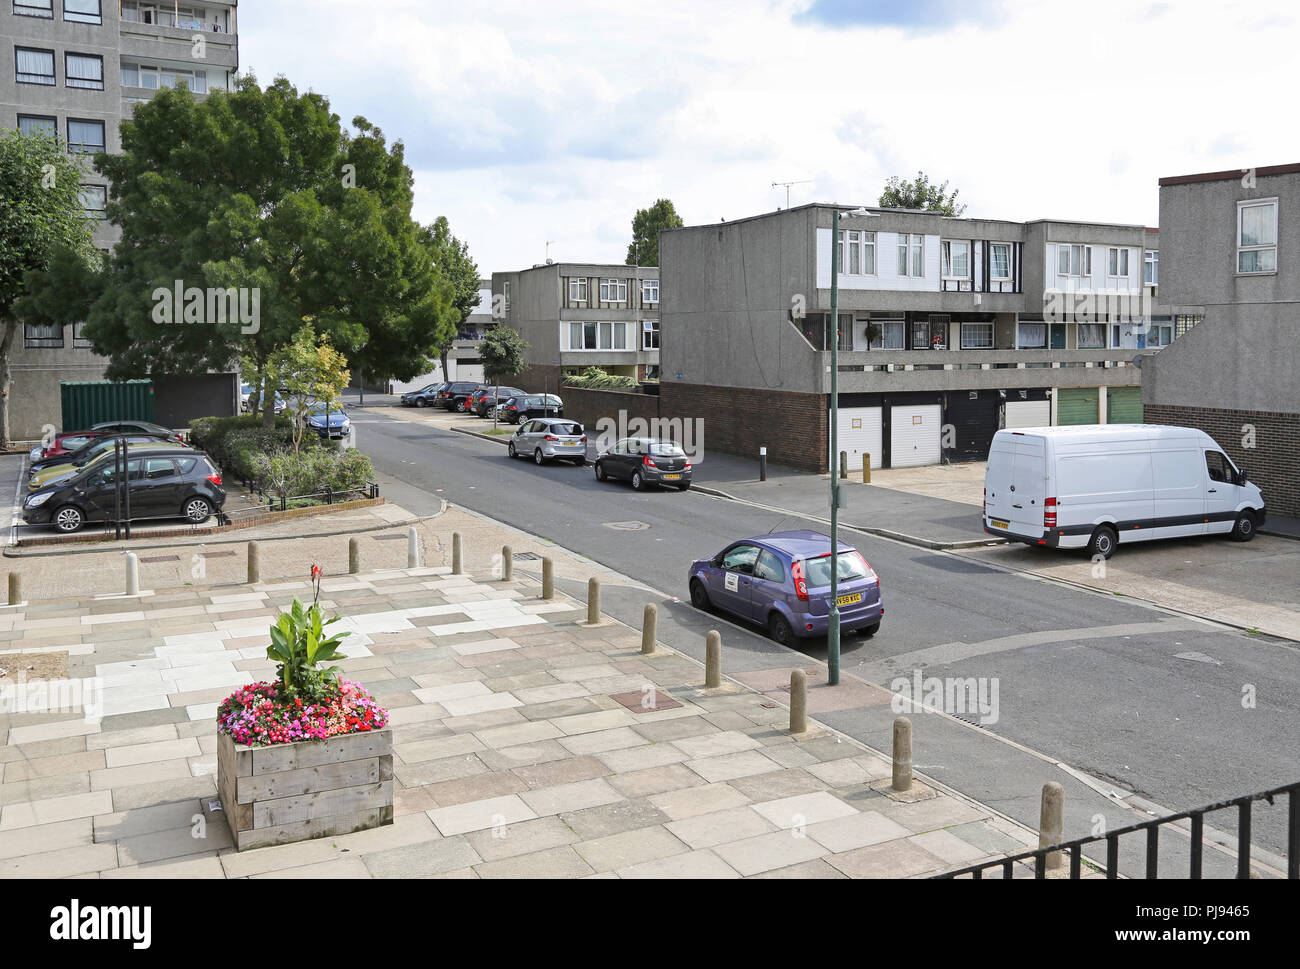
[217,727,393,851]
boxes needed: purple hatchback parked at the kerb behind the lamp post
[688,531,885,646]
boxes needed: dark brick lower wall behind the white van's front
[1143,403,1300,518]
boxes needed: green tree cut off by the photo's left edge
[0,129,99,446]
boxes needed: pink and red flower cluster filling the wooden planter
[217,680,389,747]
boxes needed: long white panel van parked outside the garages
[984,424,1264,558]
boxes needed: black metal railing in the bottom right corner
[935,782,1300,881]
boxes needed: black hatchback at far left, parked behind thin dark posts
[22,446,226,532]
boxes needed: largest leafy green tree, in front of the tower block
[16,77,446,427]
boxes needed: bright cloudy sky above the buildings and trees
[239,0,1300,271]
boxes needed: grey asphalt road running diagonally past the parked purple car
[352,410,1300,852]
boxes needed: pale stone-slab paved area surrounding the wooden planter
[0,566,1055,878]
